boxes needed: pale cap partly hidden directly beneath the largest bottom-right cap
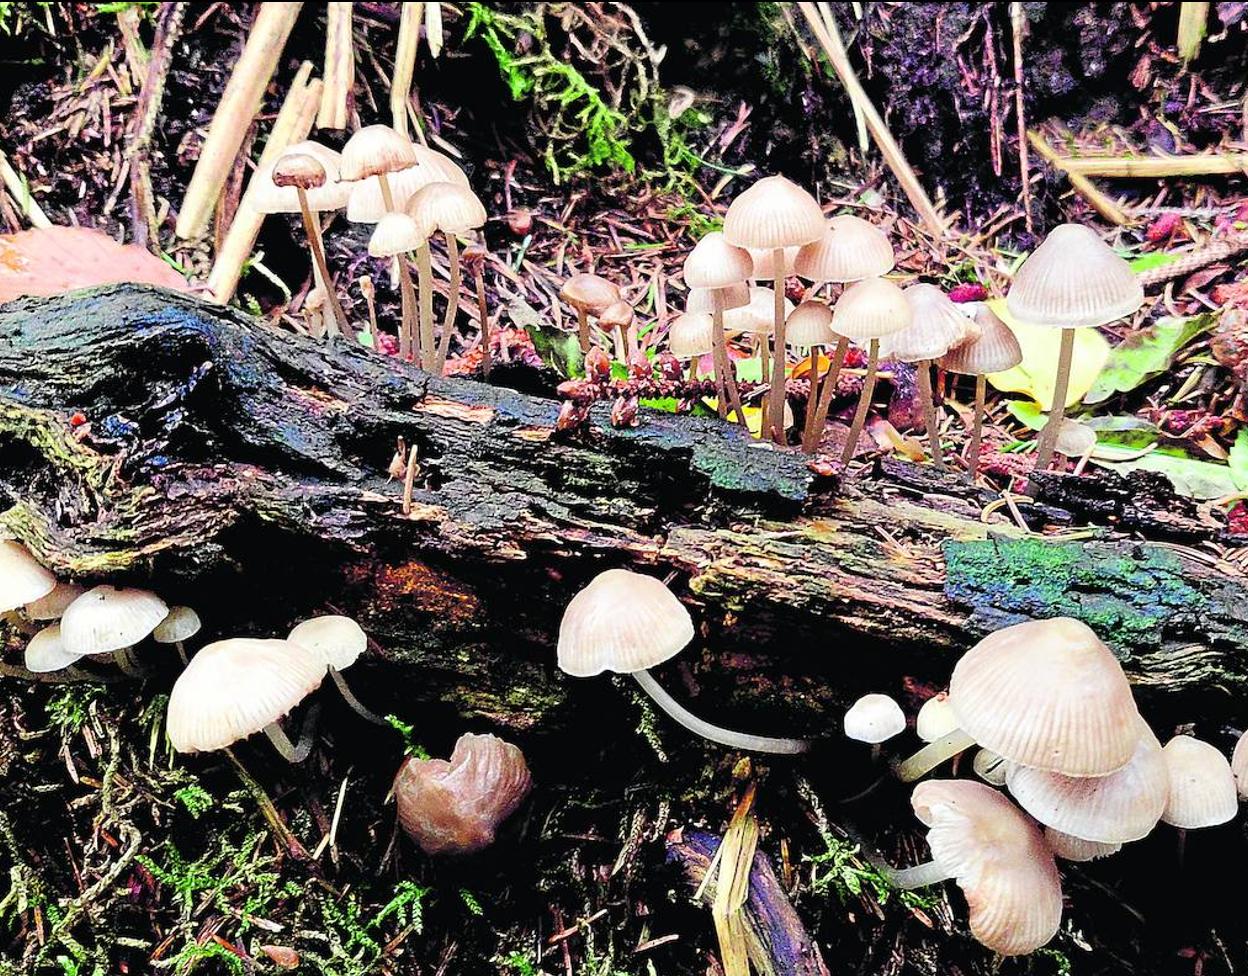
[1006,723,1169,844]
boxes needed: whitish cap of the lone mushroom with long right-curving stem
[558,569,694,678]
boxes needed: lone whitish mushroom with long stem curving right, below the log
[558,569,810,755]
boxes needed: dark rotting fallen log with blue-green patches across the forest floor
[0,286,1248,729]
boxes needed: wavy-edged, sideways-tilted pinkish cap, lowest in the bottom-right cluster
[910,780,1062,956]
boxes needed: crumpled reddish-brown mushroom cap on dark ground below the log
[394,733,533,854]
